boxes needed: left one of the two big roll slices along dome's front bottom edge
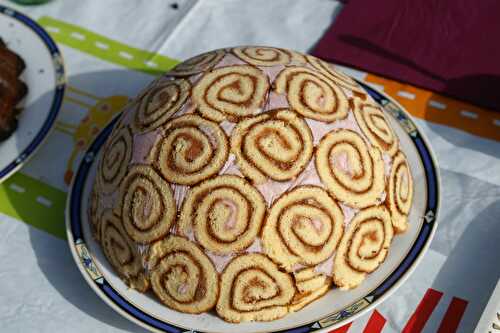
[149,235,219,313]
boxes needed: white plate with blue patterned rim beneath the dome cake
[66,81,439,333]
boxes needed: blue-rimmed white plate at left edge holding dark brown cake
[0,6,65,182]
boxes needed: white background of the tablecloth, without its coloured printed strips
[0,0,500,332]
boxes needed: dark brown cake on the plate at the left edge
[0,39,28,141]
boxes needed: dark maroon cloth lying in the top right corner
[312,0,500,110]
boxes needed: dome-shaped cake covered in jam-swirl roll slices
[89,47,413,322]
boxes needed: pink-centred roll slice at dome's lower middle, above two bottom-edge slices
[178,175,266,254]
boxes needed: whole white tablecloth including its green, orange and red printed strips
[0,0,500,332]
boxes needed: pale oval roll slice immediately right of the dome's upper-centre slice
[316,129,385,208]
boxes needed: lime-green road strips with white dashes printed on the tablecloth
[0,16,178,238]
